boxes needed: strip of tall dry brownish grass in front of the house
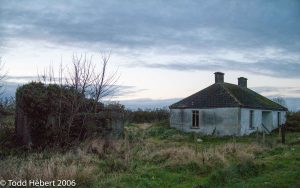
[137,143,267,167]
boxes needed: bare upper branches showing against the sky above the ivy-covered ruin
[38,53,119,102]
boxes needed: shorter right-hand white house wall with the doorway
[240,108,286,135]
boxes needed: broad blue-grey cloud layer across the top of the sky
[0,0,300,50]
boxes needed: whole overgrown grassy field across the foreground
[0,118,300,187]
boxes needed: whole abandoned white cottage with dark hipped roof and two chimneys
[169,72,287,136]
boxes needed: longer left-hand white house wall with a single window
[170,108,240,136]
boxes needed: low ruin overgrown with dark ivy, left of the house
[15,82,124,147]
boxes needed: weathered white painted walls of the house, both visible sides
[170,108,286,136]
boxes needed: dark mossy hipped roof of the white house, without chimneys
[170,83,287,111]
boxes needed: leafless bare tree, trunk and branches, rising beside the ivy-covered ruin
[38,54,118,141]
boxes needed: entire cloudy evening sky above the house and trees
[0,0,300,110]
